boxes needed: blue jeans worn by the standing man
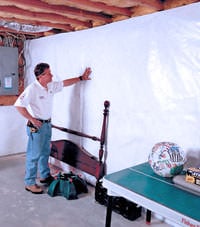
[24,123,51,185]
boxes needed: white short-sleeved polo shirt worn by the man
[14,80,63,120]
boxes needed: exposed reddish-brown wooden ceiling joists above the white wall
[0,0,199,39]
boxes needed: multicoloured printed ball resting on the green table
[148,142,185,177]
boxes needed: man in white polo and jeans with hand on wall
[14,63,91,194]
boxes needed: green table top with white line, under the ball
[105,162,200,221]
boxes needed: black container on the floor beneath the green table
[95,181,142,221]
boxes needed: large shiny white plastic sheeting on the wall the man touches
[25,3,200,172]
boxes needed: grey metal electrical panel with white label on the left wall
[0,47,18,95]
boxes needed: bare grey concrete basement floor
[0,154,169,227]
